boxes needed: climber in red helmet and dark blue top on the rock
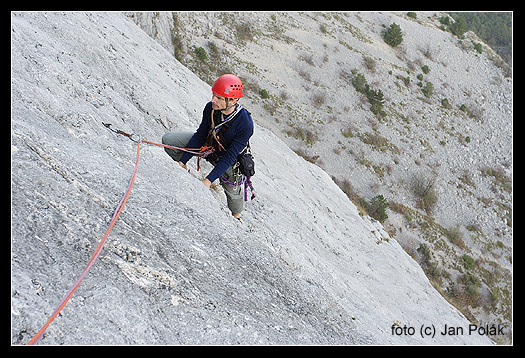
[162,74,253,220]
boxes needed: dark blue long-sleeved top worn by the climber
[180,102,253,183]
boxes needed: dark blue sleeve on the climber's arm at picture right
[207,111,253,183]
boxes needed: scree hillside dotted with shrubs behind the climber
[128,12,513,342]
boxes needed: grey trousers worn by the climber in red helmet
[162,132,244,214]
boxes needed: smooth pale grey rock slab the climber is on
[11,13,492,345]
